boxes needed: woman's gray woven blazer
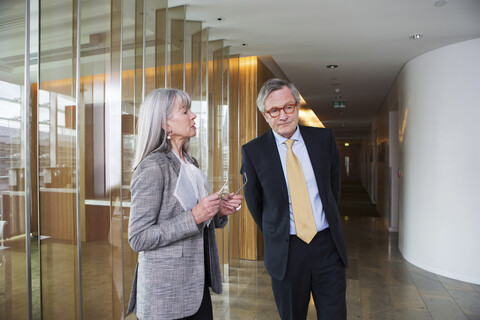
[127,151,228,320]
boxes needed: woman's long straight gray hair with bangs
[132,89,192,170]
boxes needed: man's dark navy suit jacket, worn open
[241,126,348,280]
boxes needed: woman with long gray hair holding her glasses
[128,89,242,320]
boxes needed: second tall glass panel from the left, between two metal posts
[37,0,79,319]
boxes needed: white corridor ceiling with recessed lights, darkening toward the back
[169,0,480,140]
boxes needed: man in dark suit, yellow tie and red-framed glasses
[241,79,348,320]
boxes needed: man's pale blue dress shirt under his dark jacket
[273,126,328,234]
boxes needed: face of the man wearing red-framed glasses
[262,87,298,139]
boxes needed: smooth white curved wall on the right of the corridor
[398,39,480,284]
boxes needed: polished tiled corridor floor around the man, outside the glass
[212,217,480,320]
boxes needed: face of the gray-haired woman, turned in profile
[167,97,197,140]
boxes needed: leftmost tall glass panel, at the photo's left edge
[0,2,32,319]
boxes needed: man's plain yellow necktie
[285,139,317,243]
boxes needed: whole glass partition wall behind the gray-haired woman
[0,0,238,319]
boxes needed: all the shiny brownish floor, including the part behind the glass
[0,216,480,320]
